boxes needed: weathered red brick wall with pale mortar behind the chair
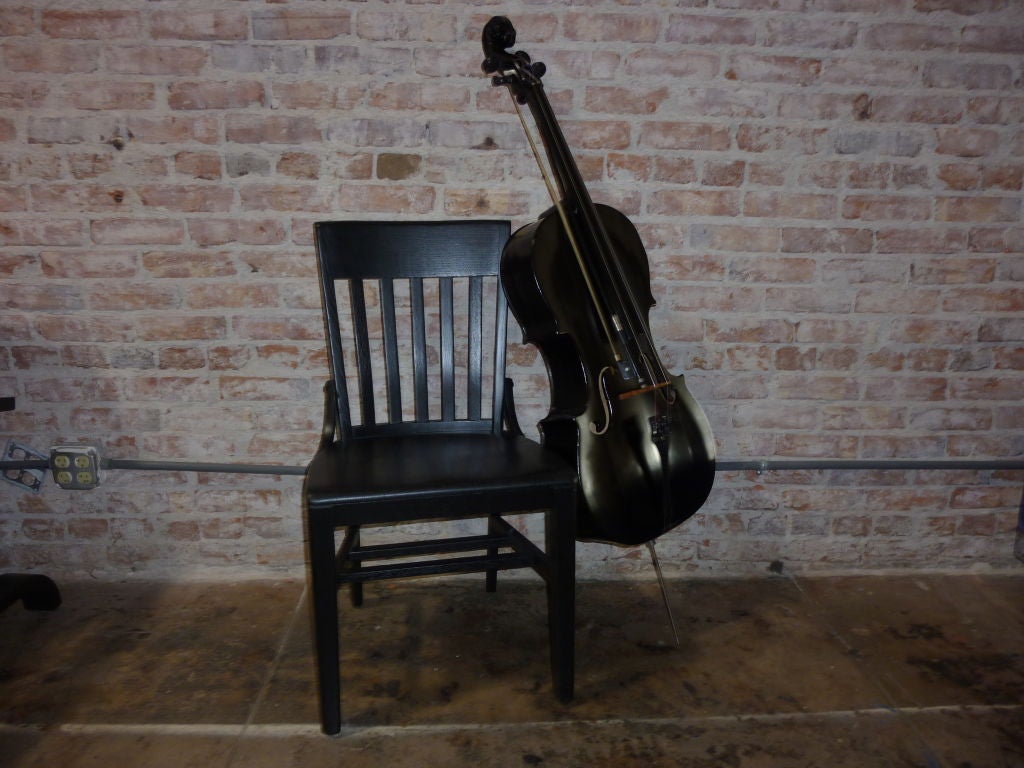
[0,0,1024,578]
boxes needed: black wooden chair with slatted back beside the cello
[303,220,575,734]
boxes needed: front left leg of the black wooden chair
[309,520,341,735]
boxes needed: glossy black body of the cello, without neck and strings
[501,206,715,545]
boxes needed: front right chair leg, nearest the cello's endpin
[544,492,575,702]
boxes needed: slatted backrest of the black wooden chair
[315,220,511,440]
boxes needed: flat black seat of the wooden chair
[306,433,575,522]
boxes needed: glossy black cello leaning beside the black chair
[482,16,715,545]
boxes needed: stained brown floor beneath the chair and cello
[0,573,1024,768]
